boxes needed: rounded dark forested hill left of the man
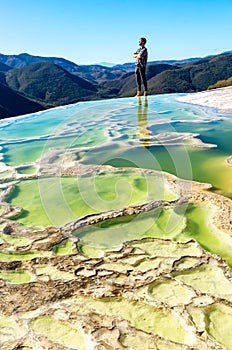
[6,62,97,106]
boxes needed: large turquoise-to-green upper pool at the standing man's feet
[0,94,232,197]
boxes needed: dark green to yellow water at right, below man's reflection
[81,145,232,198]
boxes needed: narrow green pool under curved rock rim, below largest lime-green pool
[73,208,194,256]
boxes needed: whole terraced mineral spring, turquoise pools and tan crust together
[0,94,232,350]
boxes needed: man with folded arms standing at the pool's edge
[134,38,148,96]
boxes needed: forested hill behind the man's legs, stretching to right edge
[96,54,232,98]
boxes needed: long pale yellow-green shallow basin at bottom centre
[73,297,194,345]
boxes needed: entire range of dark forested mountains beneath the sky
[0,51,232,118]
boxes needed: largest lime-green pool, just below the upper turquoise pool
[7,172,176,226]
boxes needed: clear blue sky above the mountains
[0,0,232,64]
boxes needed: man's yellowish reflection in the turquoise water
[137,96,151,147]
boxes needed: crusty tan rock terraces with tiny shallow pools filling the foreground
[0,163,232,350]
